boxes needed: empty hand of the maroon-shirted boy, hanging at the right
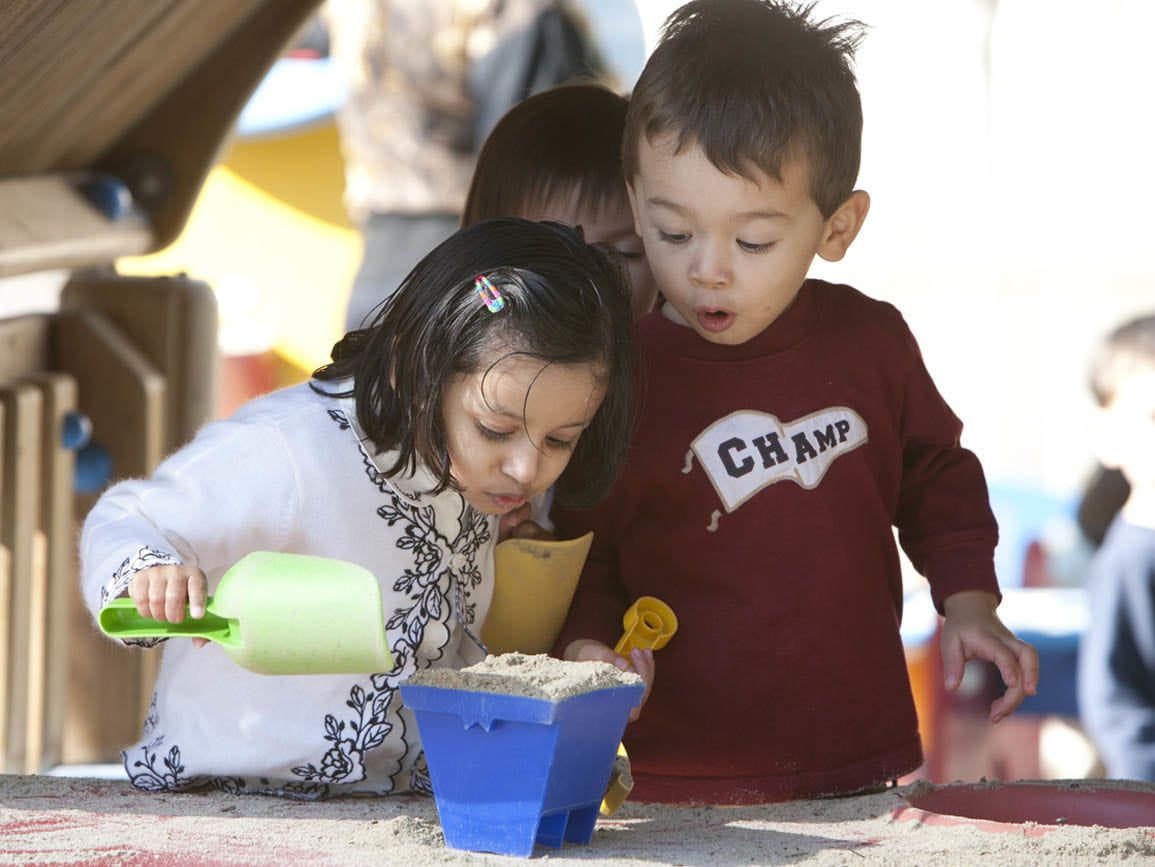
[942,591,1038,723]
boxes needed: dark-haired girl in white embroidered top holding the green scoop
[81,219,632,798]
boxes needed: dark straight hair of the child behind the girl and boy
[461,82,626,226]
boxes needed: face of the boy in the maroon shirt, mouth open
[629,133,850,345]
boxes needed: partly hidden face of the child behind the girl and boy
[528,191,657,320]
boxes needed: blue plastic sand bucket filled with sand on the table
[401,683,644,857]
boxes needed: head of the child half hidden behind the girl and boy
[462,82,657,316]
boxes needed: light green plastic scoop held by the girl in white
[98,551,393,674]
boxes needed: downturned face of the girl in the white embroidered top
[442,354,605,515]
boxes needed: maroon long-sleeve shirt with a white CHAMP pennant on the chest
[554,281,998,804]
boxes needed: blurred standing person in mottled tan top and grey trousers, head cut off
[325,0,604,329]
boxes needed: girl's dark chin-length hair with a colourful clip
[313,218,633,507]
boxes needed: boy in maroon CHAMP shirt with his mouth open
[556,0,1038,804]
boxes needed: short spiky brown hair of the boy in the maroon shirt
[621,0,863,217]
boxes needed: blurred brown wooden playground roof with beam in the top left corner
[0,0,320,276]
